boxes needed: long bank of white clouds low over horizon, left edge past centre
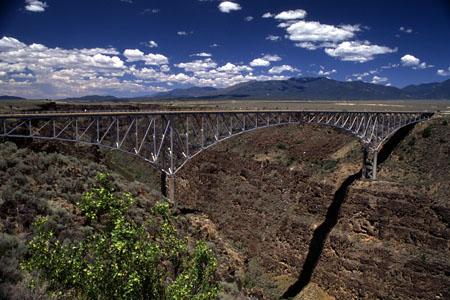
[0,37,310,98]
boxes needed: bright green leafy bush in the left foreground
[22,174,220,300]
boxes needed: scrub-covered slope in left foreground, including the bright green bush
[0,141,220,299]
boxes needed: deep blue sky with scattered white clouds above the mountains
[0,0,450,99]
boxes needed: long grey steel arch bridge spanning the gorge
[0,110,434,184]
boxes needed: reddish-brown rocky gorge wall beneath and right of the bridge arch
[177,120,450,299]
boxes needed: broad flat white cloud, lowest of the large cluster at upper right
[325,41,397,63]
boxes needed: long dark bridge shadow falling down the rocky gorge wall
[282,124,414,299]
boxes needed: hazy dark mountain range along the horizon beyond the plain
[0,77,450,101]
